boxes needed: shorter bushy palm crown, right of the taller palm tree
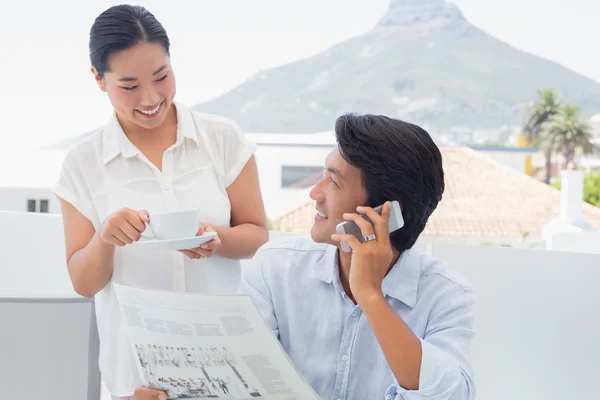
[542,105,596,165]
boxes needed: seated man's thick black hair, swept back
[335,114,445,251]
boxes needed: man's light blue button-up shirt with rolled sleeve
[241,237,475,400]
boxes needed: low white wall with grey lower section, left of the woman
[0,211,99,400]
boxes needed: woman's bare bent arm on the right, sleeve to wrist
[212,156,269,259]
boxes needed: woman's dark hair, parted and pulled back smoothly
[90,4,170,77]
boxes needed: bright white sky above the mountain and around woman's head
[0,0,600,155]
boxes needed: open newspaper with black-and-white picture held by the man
[113,283,319,400]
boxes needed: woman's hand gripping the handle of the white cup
[100,208,149,246]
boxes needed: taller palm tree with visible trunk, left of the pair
[523,89,560,183]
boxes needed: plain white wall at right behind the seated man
[432,244,600,400]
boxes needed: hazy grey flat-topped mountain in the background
[195,0,600,133]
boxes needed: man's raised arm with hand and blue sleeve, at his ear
[332,202,475,400]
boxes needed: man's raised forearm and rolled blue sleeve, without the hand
[360,287,475,400]
